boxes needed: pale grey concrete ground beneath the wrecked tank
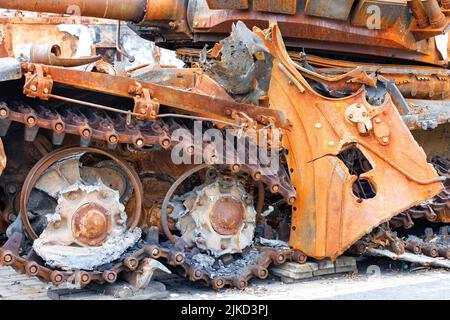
[0,262,450,300]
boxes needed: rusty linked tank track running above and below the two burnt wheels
[0,102,298,290]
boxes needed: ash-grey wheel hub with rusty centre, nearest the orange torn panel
[172,178,256,258]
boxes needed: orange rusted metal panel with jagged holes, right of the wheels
[255,26,443,259]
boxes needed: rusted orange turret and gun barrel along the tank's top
[0,0,450,65]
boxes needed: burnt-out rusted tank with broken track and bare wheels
[0,0,450,289]
